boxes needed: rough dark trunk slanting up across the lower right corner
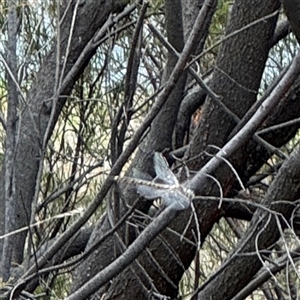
[193,147,300,300]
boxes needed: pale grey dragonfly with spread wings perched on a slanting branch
[128,152,195,210]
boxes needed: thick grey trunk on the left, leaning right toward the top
[0,0,128,264]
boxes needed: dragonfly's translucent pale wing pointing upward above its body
[153,152,178,185]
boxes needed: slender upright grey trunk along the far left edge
[0,1,19,281]
